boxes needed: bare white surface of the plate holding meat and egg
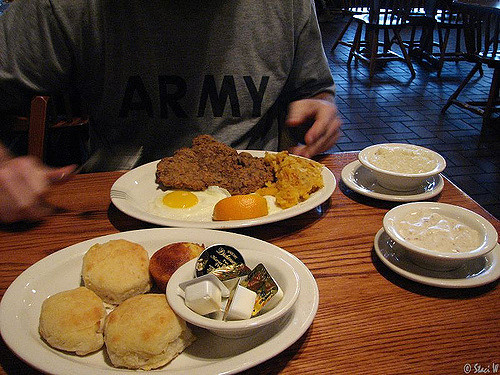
[110,150,336,229]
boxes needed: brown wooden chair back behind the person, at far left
[14,96,88,161]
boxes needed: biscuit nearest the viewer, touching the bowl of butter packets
[104,294,195,370]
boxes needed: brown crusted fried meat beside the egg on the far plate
[156,135,274,195]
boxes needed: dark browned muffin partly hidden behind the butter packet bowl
[149,242,205,292]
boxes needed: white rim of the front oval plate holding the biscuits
[0,228,319,375]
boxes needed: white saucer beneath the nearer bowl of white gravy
[373,227,500,289]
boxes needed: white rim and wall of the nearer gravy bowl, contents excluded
[383,202,498,271]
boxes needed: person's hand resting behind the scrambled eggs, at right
[286,94,341,158]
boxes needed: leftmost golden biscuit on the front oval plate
[38,287,106,355]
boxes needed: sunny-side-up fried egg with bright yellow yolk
[151,186,231,221]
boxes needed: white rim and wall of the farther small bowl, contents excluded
[358,143,446,191]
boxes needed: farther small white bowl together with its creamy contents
[358,143,446,191]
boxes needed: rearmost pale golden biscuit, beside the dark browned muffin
[82,239,152,305]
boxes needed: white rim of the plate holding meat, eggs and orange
[110,150,337,229]
